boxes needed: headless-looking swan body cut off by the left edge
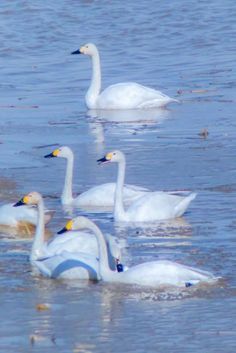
[0,199,53,235]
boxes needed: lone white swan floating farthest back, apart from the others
[71,43,178,109]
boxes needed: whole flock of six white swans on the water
[0,44,217,287]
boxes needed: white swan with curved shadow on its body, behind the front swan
[15,192,121,279]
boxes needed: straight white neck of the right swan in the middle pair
[114,159,126,220]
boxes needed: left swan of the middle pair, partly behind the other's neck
[44,146,149,207]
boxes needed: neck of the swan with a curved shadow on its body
[30,199,45,261]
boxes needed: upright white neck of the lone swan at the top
[85,50,101,109]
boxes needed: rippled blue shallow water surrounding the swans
[0,0,236,353]
